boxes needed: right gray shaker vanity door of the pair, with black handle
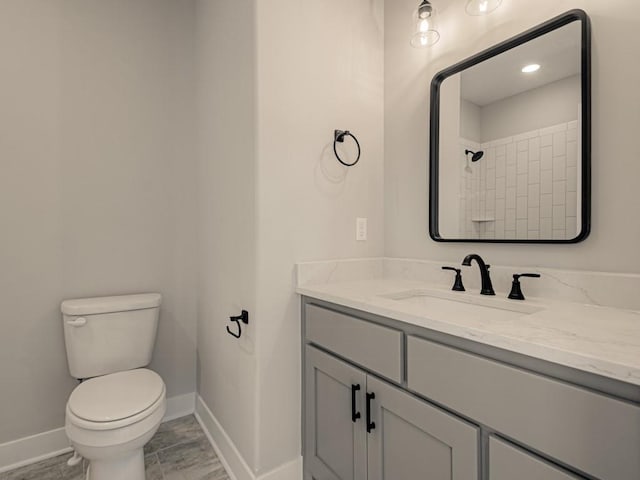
[367,377,479,480]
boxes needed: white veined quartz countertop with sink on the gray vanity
[296,278,640,385]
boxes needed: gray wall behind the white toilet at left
[0,0,196,443]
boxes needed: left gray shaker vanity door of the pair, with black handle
[305,346,367,480]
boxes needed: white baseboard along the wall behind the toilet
[0,392,196,473]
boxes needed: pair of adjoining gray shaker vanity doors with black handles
[305,346,479,480]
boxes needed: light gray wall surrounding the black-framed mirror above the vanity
[385,0,640,273]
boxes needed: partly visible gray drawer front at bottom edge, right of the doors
[489,436,584,480]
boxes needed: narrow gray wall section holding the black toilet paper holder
[196,0,259,466]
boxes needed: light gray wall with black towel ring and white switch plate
[255,0,384,472]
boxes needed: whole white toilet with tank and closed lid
[61,293,166,480]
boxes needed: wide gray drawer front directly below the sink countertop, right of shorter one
[407,336,640,480]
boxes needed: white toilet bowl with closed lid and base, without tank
[65,368,166,480]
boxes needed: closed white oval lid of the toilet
[68,368,165,422]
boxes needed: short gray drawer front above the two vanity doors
[305,305,402,383]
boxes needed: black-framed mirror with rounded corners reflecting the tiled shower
[429,10,591,243]
